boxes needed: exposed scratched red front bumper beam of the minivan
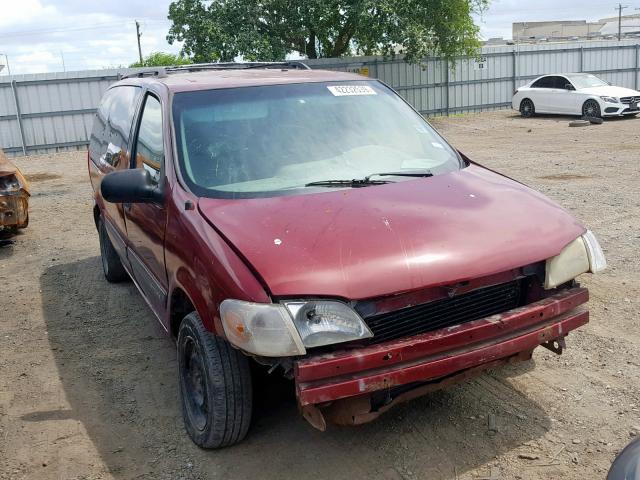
[294,288,589,430]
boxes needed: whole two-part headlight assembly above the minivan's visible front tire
[220,300,373,357]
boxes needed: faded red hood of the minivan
[199,165,584,300]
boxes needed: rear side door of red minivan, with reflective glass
[89,86,142,261]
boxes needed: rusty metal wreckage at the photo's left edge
[0,150,30,234]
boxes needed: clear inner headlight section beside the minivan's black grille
[285,300,373,348]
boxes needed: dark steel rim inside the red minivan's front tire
[180,336,209,431]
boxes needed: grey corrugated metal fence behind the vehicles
[0,41,640,155]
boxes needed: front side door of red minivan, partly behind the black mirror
[124,93,167,316]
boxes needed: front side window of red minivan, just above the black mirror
[135,95,164,184]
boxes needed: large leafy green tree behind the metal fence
[167,0,489,62]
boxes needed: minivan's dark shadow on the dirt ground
[40,257,550,480]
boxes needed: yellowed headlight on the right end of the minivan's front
[544,230,607,289]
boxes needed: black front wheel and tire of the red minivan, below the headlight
[177,312,253,449]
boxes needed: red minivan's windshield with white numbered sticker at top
[173,81,462,198]
